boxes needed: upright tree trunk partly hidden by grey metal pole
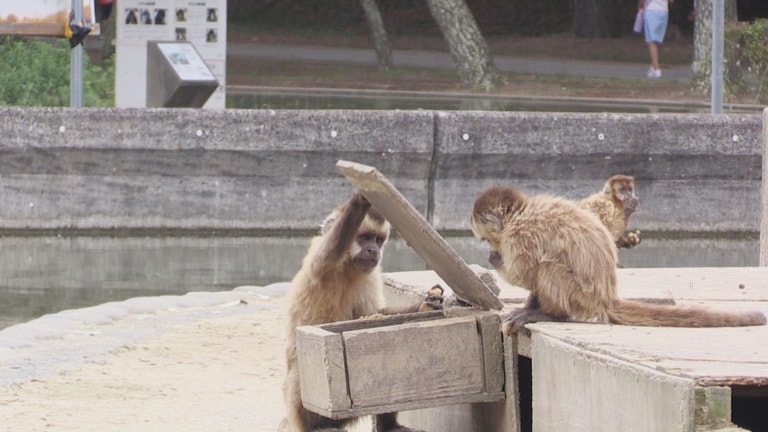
[691,0,740,93]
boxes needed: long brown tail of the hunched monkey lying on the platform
[609,300,766,327]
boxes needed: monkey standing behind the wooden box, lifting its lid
[280,193,443,432]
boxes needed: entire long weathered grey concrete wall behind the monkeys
[0,108,761,232]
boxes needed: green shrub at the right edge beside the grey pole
[726,19,768,103]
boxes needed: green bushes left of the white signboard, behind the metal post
[0,37,115,106]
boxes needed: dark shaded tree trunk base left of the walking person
[572,0,622,38]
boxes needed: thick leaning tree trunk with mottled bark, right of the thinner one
[427,0,501,91]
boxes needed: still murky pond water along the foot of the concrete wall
[0,237,759,328]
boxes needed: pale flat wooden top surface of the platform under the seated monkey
[387,267,768,386]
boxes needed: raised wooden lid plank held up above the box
[336,160,502,310]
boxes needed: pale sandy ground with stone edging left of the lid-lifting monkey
[0,287,292,432]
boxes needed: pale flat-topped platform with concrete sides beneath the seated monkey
[386,268,768,432]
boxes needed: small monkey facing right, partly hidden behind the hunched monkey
[578,174,640,248]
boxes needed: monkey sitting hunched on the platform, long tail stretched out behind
[470,186,766,334]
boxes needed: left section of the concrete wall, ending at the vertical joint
[0,108,434,229]
